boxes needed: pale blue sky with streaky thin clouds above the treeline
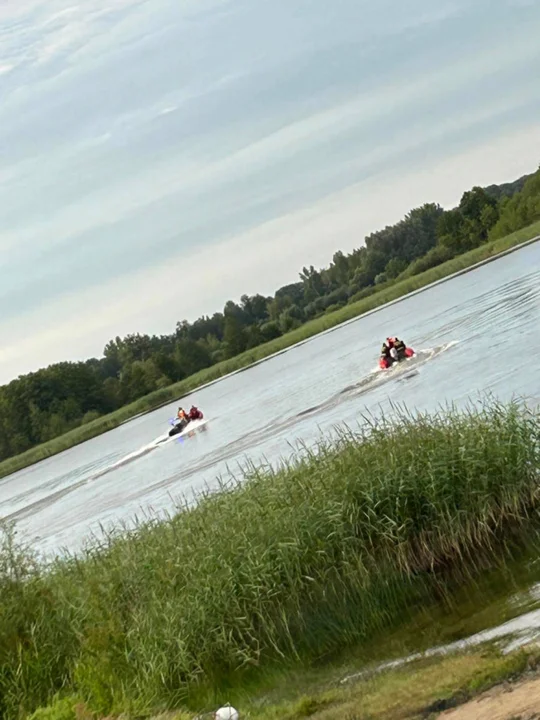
[0,0,540,382]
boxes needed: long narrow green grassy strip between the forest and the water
[0,222,540,478]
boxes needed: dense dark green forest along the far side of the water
[0,169,540,460]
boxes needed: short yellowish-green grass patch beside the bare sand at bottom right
[233,646,540,720]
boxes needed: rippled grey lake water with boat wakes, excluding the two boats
[0,243,540,553]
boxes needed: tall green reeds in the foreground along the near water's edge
[0,405,540,718]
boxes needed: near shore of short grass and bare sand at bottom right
[240,643,540,720]
